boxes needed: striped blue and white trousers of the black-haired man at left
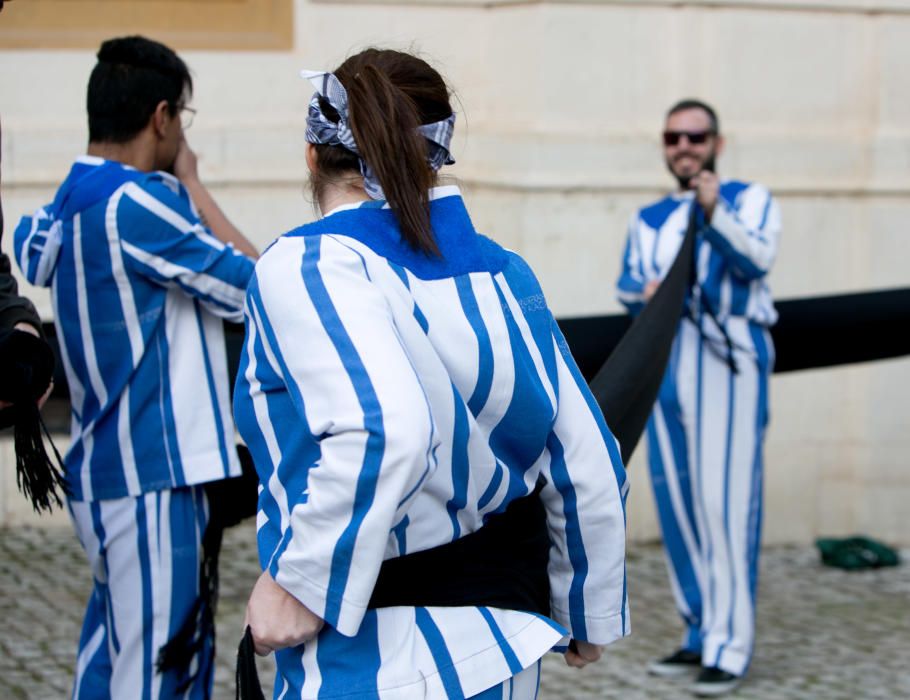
[69,486,214,700]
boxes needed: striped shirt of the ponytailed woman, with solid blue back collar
[234,187,629,699]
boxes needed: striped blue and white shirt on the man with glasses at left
[15,156,253,501]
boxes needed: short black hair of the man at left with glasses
[86,36,193,143]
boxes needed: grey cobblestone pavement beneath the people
[0,526,910,700]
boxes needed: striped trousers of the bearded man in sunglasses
[648,318,774,675]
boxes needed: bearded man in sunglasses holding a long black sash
[617,100,780,696]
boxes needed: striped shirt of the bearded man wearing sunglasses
[617,180,781,326]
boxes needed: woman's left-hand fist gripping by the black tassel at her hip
[244,571,324,656]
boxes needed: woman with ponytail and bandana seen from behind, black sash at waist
[234,49,629,700]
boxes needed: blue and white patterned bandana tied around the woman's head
[300,70,455,199]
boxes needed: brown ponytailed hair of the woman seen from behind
[312,49,452,255]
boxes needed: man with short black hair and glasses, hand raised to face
[15,36,256,700]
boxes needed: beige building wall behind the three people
[0,0,910,545]
